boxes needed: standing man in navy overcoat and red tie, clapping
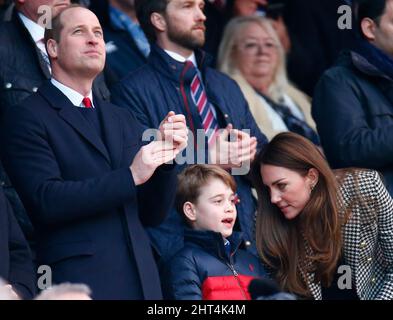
[2,6,187,299]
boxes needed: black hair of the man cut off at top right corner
[353,0,387,37]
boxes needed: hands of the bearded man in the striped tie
[209,124,257,169]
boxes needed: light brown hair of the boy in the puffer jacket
[176,164,236,214]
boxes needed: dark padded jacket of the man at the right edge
[312,51,393,194]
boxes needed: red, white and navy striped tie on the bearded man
[186,61,219,145]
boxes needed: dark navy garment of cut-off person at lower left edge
[0,188,35,299]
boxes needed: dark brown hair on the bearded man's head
[135,0,170,43]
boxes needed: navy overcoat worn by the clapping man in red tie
[2,82,176,299]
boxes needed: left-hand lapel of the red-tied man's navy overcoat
[38,81,111,164]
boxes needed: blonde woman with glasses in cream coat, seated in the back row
[218,16,319,144]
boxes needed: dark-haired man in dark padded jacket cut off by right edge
[312,0,393,195]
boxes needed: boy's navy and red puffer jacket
[162,228,266,300]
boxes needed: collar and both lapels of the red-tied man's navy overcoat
[38,81,122,167]
